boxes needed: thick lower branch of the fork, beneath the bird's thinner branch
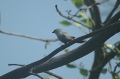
[33,22,120,72]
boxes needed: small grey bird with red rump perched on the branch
[52,29,85,44]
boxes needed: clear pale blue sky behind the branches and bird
[0,0,120,79]
